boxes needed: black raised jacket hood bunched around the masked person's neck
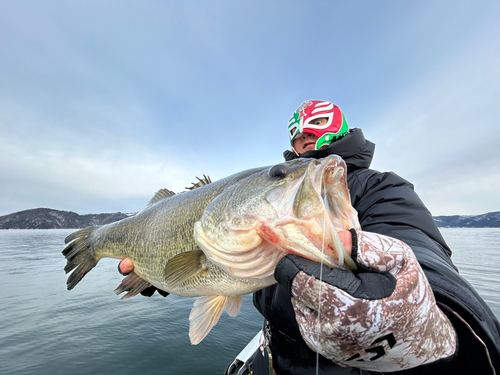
[283,128,375,172]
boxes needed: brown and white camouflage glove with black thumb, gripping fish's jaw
[275,230,457,371]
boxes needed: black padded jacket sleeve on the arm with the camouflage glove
[349,169,500,374]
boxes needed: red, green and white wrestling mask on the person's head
[288,100,349,153]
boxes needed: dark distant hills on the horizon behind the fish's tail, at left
[0,208,132,229]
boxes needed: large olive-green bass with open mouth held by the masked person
[62,155,360,345]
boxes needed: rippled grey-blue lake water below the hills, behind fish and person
[0,228,500,375]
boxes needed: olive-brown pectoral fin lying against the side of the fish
[163,250,205,288]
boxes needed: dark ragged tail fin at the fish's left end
[62,227,99,290]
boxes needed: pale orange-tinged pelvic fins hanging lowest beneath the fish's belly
[189,295,242,345]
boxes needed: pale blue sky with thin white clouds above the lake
[0,0,500,216]
